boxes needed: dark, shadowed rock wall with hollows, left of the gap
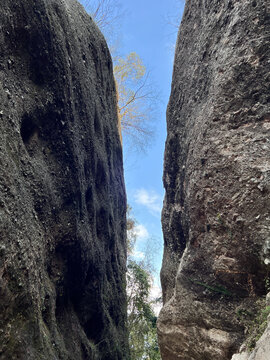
[0,0,128,360]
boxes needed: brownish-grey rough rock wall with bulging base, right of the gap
[158,0,270,360]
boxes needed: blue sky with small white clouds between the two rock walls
[81,0,184,290]
